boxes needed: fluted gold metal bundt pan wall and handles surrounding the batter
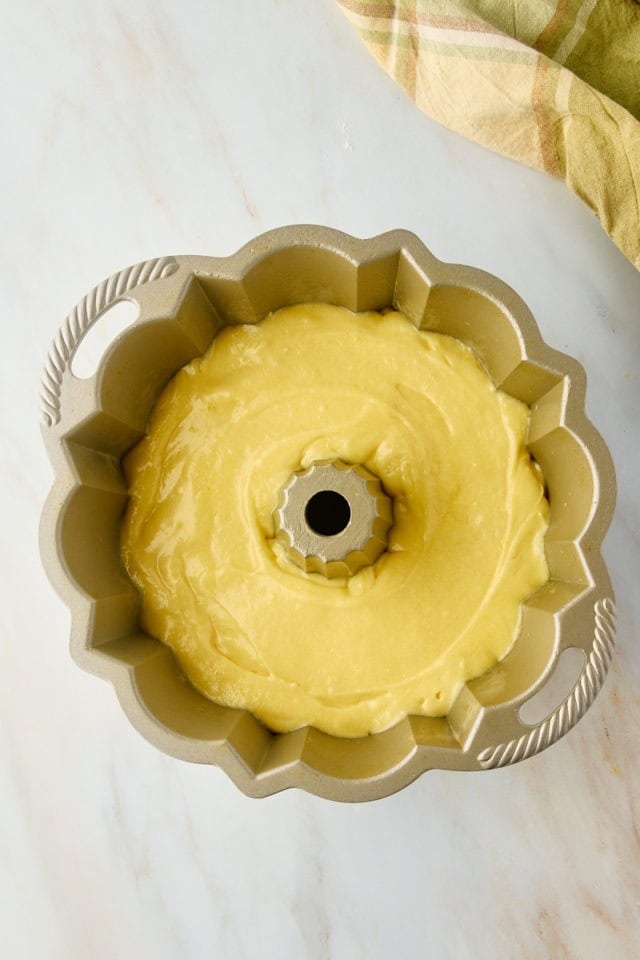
[41,226,615,801]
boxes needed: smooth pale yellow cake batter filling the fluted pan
[122,304,548,737]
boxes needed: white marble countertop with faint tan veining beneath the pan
[0,0,640,960]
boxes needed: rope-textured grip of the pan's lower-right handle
[478,597,616,770]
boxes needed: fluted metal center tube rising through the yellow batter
[274,460,393,578]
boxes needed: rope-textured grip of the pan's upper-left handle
[40,257,179,427]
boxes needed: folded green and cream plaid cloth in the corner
[338,0,640,269]
